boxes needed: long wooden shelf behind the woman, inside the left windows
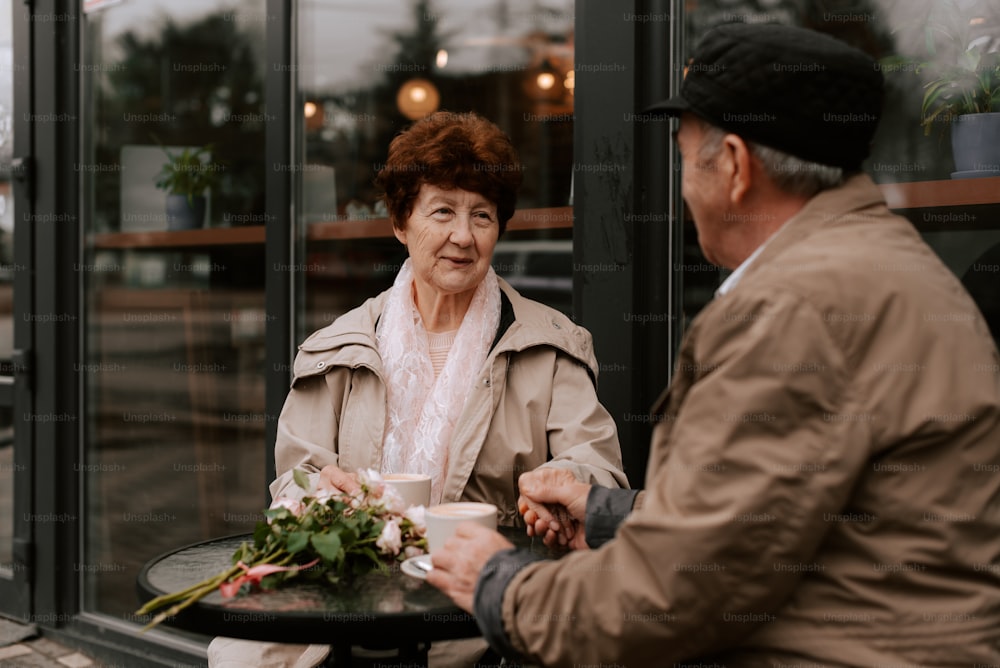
[93,206,573,249]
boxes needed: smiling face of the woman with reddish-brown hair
[393,183,500,306]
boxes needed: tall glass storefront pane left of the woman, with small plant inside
[80,0,268,619]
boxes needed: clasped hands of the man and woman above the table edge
[517,468,590,550]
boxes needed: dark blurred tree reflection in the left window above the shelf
[88,11,267,229]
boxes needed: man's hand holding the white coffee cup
[427,522,514,613]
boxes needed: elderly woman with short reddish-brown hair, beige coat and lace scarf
[210,112,628,666]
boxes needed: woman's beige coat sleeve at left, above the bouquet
[270,369,347,499]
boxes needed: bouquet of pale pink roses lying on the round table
[135,469,427,631]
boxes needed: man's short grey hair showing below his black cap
[694,116,844,197]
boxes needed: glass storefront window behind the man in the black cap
[682,0,1000,339]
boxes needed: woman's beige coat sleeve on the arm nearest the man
[544,353,629,489]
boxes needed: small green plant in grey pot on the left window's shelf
[156,144,222,230]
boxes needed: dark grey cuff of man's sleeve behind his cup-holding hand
[473,548,545,661]
